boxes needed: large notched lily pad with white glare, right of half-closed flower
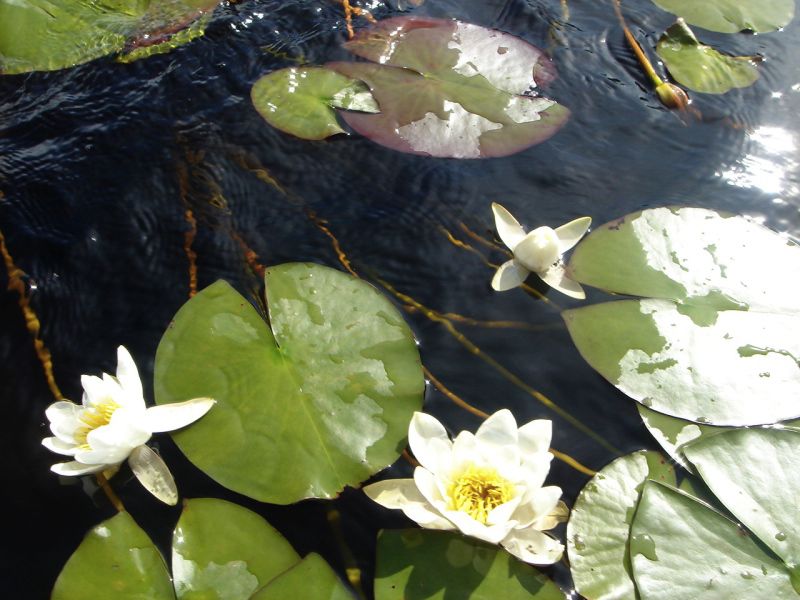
[563,208,800,425]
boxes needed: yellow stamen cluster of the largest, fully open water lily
[447,465,515,525]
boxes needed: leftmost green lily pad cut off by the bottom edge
[51,512,175,600]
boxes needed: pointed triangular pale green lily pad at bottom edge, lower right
[631,482,797,600]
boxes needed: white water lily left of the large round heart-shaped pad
[42,346,215,504]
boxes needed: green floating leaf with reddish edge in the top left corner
[0,0,219,74]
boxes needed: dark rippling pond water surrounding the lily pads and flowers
[0,0,800,598]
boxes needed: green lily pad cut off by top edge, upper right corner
[653,0,794,33]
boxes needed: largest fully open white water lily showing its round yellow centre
[364,409,568,565]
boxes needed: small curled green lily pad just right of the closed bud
[656,19,759,94]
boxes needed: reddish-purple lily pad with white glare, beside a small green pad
[328,17,569,158]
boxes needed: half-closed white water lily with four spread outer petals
[492,202,592,300]
